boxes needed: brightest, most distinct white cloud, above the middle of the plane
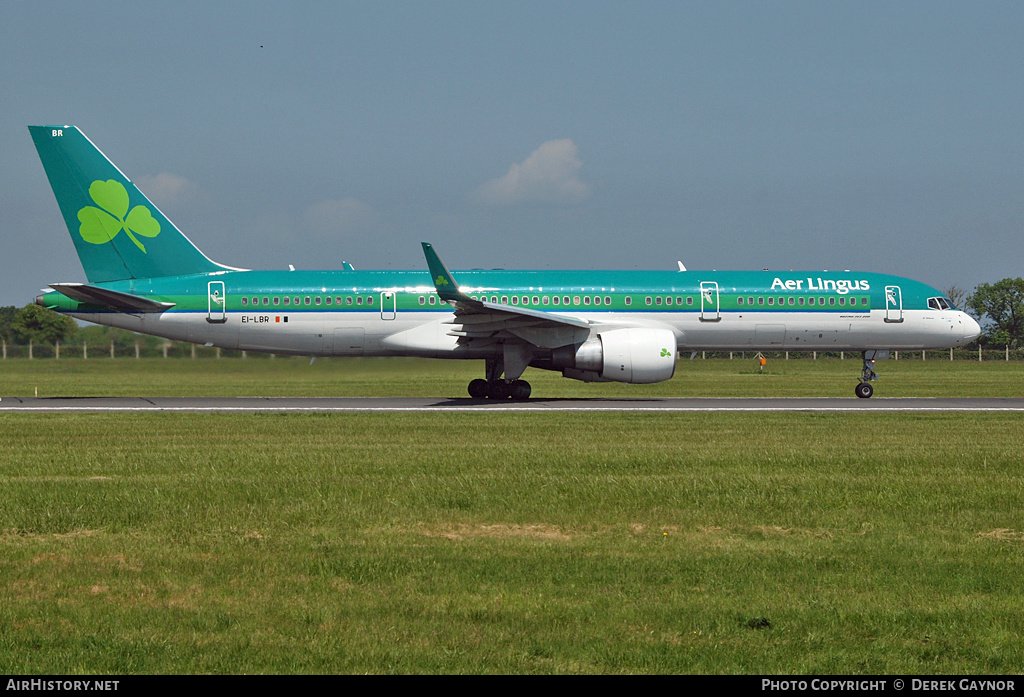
[474,138,590,206]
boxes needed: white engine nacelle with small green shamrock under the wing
[552,328,676,384]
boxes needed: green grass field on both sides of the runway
[0,359,1024,673]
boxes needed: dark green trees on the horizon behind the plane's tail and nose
[0,276,1024,349]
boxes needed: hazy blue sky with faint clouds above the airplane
[0,0,1024,305]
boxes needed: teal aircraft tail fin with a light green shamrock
[29,126,227,284]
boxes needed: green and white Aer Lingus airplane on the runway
[29,126,981,400]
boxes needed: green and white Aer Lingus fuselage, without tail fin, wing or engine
[41,270,976,358]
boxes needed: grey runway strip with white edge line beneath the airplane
[0,397,1024,413]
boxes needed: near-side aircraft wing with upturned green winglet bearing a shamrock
[423,243,592,348]
